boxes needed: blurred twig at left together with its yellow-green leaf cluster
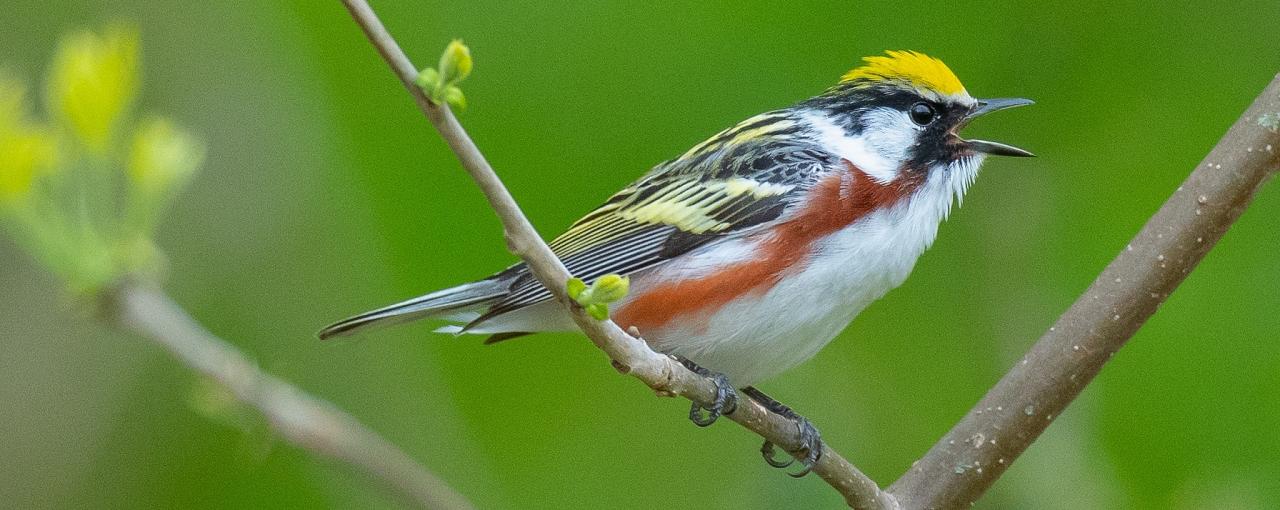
[0,26,471,509]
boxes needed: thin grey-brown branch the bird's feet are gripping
[343,0,893,509]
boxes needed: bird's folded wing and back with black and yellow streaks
[467,110,838,328]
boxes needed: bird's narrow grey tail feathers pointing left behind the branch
[319,279,509,340]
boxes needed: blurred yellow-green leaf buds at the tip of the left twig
[0,27,204,292]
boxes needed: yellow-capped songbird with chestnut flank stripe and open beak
[319,50,1033,474]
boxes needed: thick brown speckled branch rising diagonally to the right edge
[890,76,1280,509]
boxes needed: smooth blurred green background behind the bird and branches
[0,0,1280,509]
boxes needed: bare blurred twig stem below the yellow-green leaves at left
[106,283,472,509]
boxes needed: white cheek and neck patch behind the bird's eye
[805,108,919,183]
